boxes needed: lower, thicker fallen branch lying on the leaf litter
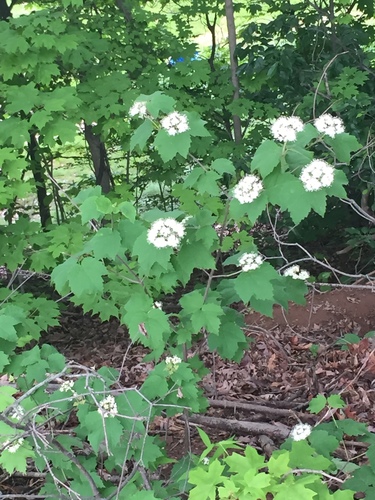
[189,415,290,439]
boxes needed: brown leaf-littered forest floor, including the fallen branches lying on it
[1,288,375,498]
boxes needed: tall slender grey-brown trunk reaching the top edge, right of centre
[225,0,242,144]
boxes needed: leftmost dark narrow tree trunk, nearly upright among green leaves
[29,133,52,228]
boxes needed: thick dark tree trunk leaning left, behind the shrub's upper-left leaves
[85,125,114,194]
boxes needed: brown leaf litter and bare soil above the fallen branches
[43,288,375,432]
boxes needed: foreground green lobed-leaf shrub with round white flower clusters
[0,92,370,500]
